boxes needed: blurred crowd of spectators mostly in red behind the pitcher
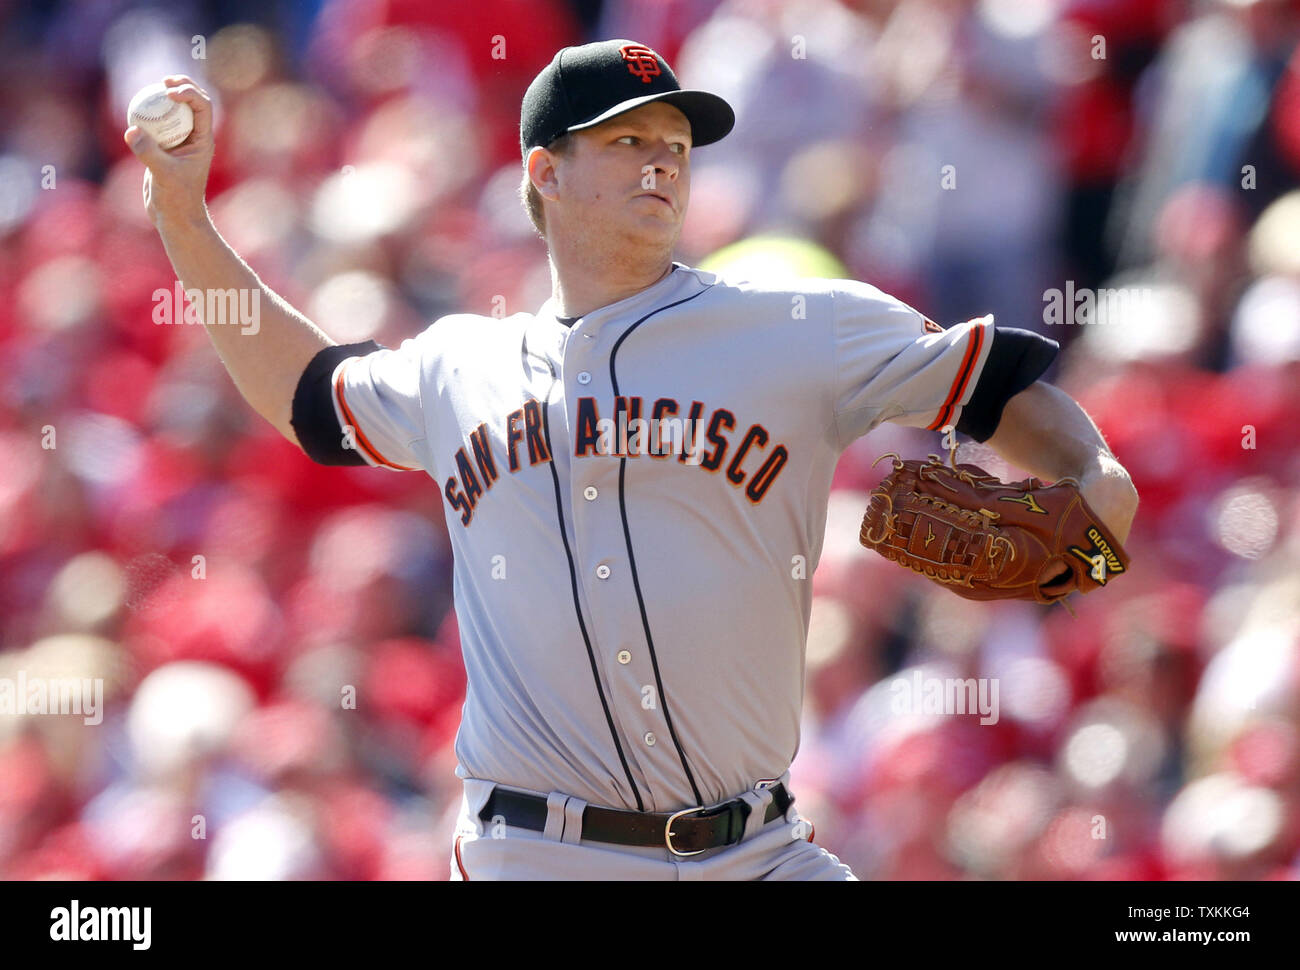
[0,0,1300,879]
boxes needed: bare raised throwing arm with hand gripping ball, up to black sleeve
[124,74,334,445]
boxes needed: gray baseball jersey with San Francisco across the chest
[287,263,1054,878]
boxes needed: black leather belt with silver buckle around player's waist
[478,783,794,856]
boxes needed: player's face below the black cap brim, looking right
[562,101,690,250]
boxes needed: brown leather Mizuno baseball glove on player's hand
[859,454,1128,609]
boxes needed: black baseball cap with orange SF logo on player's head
[519,40,736,159]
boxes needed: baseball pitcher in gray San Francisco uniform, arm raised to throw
[125,40,1136,880]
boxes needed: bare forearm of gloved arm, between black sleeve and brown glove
[988,381,1138,542]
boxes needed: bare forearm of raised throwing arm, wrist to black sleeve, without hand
[157,211,334,445]
